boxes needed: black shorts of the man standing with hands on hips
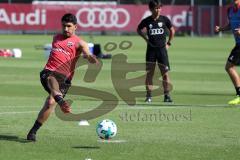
[146,46,170,71]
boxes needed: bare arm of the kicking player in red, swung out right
[79,40,99,64]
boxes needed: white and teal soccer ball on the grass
[96,119,117,139]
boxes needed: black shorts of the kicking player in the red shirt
[40,69,71,96]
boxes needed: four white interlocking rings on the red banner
[76,8,130,28]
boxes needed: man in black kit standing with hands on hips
[137,0,175,103]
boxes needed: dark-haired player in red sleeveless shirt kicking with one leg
[27,13,98,141]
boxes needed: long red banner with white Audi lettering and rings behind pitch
[0,4,219,32]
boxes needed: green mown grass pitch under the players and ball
[0,35,240,160]
